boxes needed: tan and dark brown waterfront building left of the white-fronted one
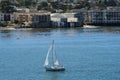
[14,12,50,28]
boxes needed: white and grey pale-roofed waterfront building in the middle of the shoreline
[51,13,83,27]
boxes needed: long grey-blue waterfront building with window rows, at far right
[87,7,120,26]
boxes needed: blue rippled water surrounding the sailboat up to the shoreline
[0,27,120,80]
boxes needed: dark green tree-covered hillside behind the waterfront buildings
[0,0,120,13]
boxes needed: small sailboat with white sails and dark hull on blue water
[44,40,65,71]
